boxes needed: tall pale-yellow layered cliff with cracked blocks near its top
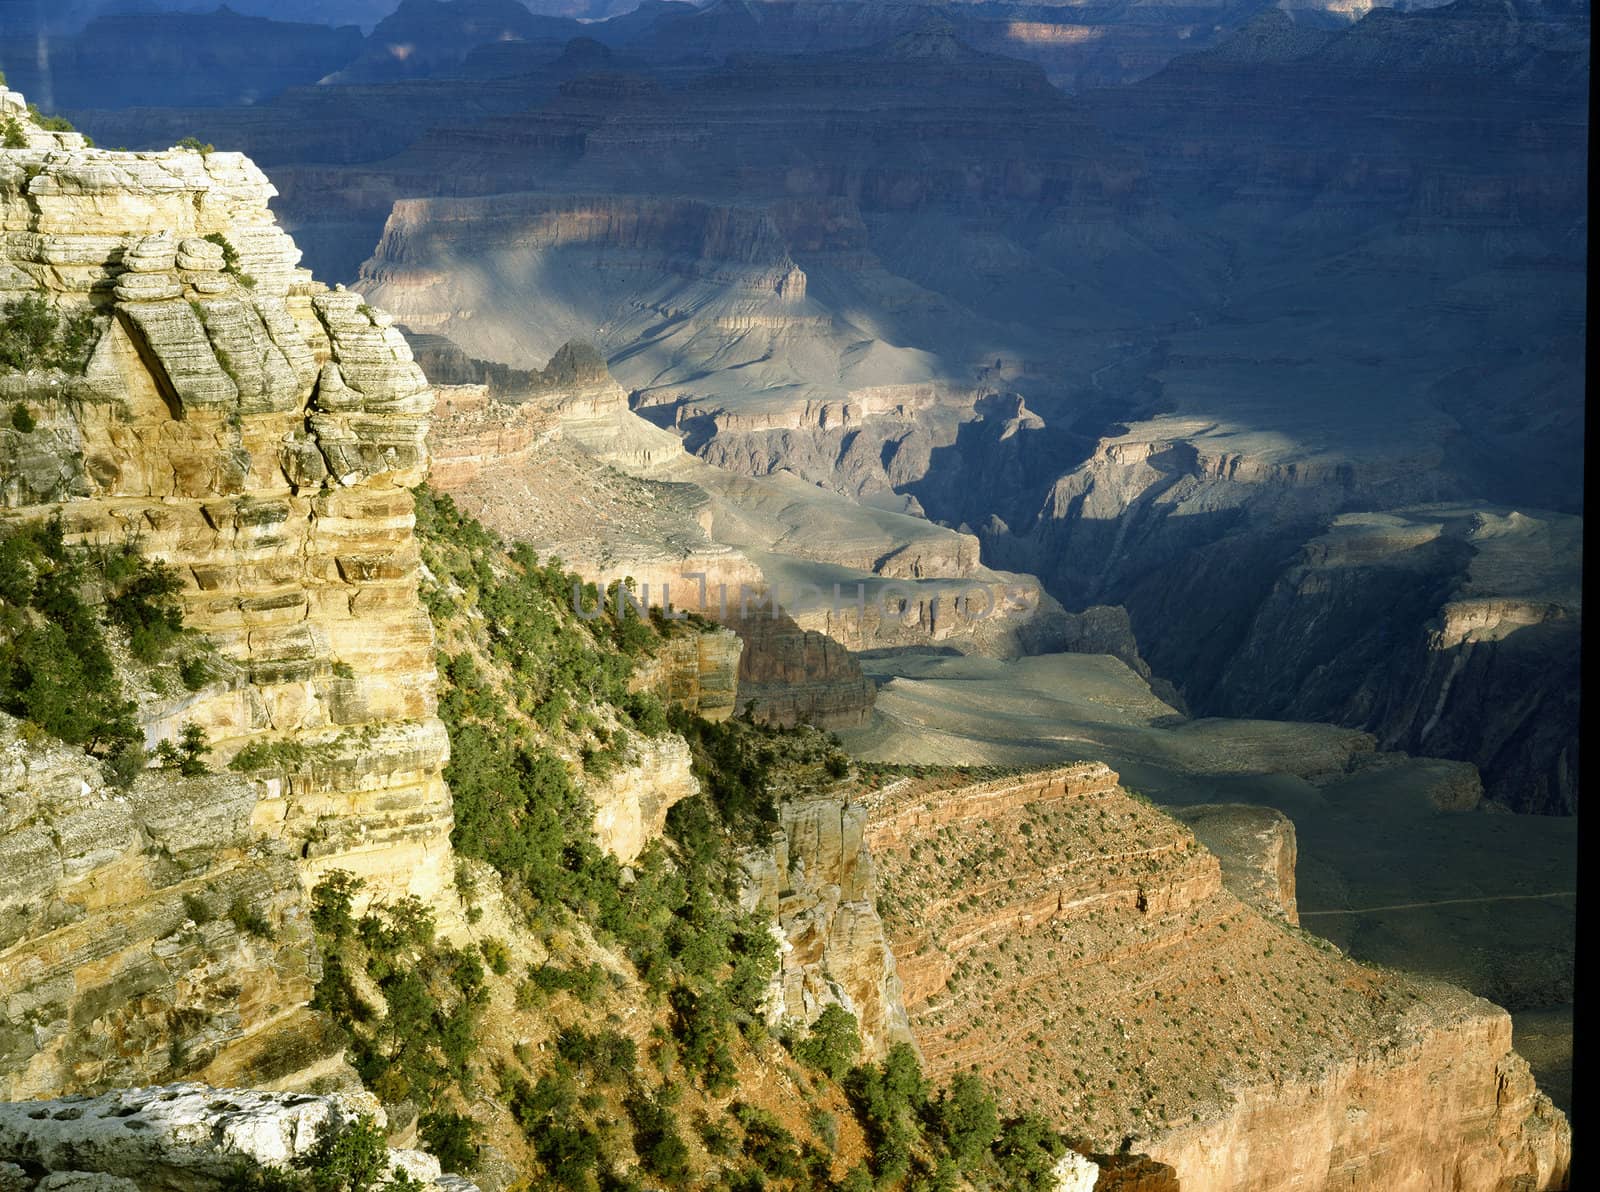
[0,100,450,894]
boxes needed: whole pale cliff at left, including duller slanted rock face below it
[0,93,451,1096]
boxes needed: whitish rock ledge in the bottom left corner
[0,1085,475,1192]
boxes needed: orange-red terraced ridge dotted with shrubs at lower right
[867,763,1571,1189]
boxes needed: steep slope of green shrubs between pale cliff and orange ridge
[315,491,1094,1192]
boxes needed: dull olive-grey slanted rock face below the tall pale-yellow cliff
[0,714,329,1100]
